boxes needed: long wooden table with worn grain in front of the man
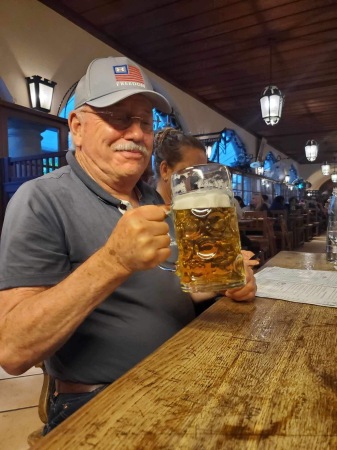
[34,252,337,450]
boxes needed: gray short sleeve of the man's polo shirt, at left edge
[0,180,70,289]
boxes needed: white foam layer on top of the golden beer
[172,189,231,209]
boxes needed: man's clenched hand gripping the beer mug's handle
[105,205,170,274]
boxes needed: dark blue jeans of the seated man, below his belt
[42,385,108,436]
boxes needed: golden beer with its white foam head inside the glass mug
[172,189,245,292]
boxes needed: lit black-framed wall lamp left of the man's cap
[26,75,57,112]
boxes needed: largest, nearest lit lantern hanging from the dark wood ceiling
[260,39,284,126]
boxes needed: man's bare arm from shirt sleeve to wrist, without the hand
[0,247,129,375]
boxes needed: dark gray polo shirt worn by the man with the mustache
[0,151,195,383]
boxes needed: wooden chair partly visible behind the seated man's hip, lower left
[27,362,55,448]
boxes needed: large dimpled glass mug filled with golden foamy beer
[162,163,245,292]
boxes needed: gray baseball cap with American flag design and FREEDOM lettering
[75,56,172,114]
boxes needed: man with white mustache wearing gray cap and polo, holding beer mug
[0,57,256,432]
